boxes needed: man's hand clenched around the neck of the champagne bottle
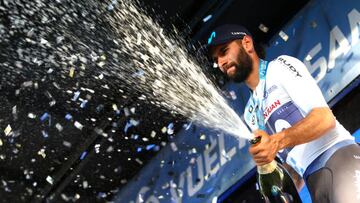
[249,130,280,166]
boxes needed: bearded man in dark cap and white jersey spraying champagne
[208,25,360,203]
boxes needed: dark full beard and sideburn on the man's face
[230,47,253,83]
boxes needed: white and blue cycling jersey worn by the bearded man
[244,55,354,176]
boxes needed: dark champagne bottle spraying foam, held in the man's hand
[250,137,301,203]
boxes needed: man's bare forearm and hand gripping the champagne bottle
[249,107,335,166]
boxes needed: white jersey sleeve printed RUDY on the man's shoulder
[271,55,328,114]
